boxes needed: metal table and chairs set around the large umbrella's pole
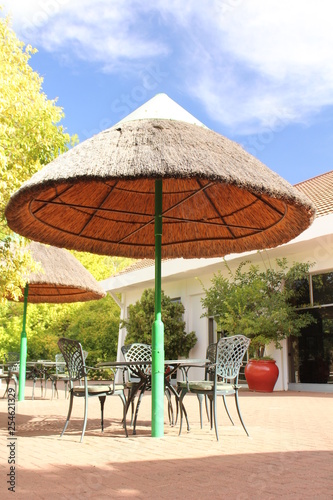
[58,335,250,442]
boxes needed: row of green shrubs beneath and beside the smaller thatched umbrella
[0,296,119,365]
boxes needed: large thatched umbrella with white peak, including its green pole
[6,94,315,436]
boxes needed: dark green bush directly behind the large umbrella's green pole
[121,289,197,359]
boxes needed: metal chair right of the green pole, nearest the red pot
[178,335,250,440]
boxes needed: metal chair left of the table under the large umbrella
[58,338,128,442]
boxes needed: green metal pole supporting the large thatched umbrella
[151,179,164,437]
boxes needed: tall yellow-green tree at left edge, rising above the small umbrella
[0,18,77,300]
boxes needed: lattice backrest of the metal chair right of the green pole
[215,335,251,382]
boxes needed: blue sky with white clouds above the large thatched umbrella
[0,0,333,184]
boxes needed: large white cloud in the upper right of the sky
[174,0,333,134]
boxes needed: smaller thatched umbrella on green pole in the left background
[8,242,106,401]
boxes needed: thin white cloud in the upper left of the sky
[3,0,168,68]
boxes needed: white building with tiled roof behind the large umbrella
[101,171,333,392]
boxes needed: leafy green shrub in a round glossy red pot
[202,258,314,392]
